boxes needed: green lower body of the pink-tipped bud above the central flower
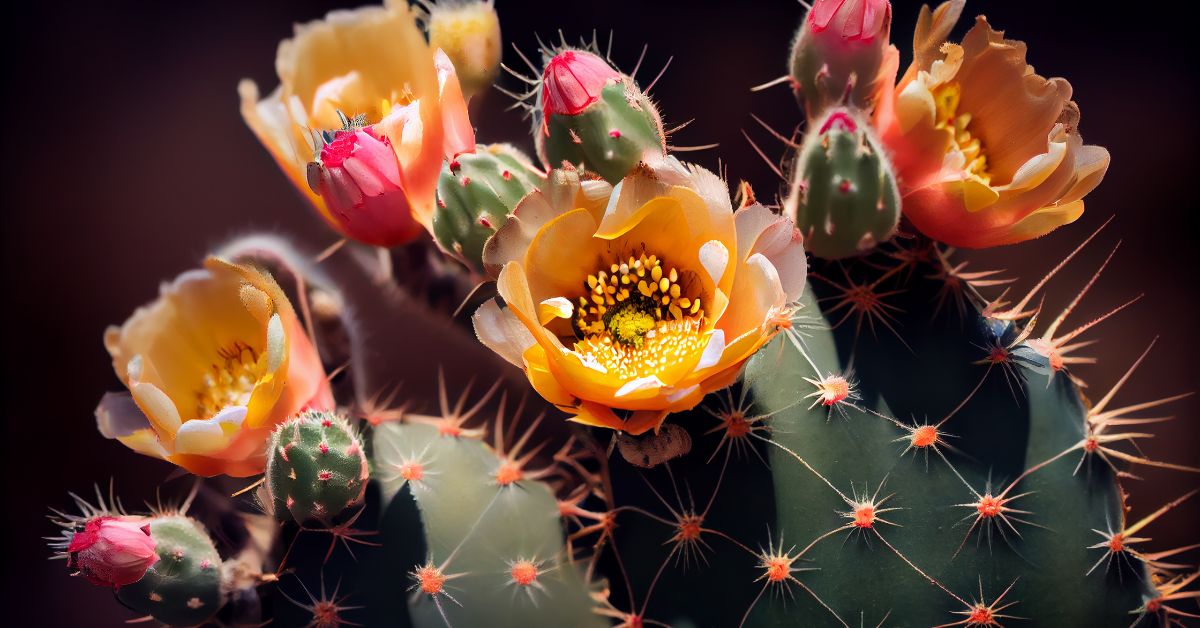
[534,79,666,185]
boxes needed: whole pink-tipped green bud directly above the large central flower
[532,49,666,184]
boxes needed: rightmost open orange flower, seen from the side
[876,2,1109,249]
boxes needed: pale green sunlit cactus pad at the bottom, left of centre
[373,424,605,628]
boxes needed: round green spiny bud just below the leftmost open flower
[265,411,370,524]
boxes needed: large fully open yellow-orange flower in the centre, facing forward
[474,157,806,435]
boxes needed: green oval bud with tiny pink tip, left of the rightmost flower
[785,109,900,259]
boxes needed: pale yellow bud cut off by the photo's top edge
[425,0,503,100]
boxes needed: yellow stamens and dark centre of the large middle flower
[575,253,706,378]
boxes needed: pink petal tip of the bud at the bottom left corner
[67,515,158,588]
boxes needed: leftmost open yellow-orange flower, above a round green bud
[96,258,332,477]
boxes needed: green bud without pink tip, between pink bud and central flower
[433,144,545,273]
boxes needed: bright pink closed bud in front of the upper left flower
[308,127,421,246]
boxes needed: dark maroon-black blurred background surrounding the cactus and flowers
[0,0,1200,626]
